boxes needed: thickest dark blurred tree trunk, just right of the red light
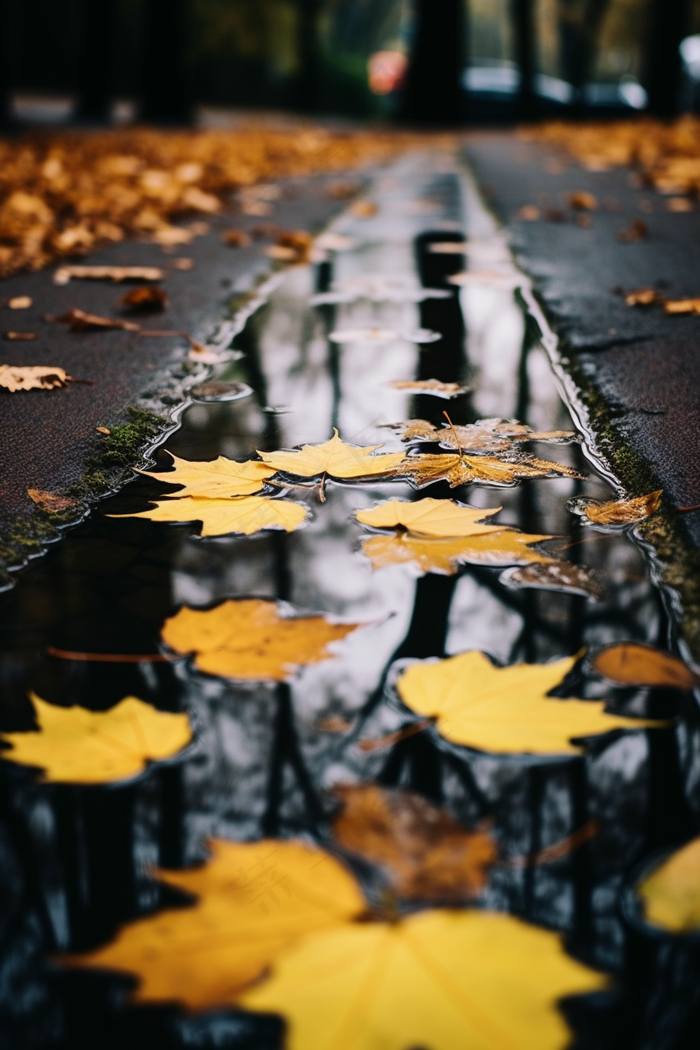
[402,0,466,124]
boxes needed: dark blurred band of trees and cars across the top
[0,0,700,124]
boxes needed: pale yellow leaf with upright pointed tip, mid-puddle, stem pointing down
[258,429,404,480]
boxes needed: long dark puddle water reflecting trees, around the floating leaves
[0,156,698,1050]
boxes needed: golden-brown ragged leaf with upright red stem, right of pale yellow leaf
[396,453,581,488]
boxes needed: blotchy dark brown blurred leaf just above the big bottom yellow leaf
[332,783,496,904]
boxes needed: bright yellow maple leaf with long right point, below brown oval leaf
[397,651,662,755]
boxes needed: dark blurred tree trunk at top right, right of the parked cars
[644,0,691,117]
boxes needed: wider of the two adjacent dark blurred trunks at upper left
[140,0,192,124]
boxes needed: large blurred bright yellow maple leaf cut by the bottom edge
[240,909,608,1050]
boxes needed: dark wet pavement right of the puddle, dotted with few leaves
[466,131,700,547]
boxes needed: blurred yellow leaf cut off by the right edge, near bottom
[637,838,700,933]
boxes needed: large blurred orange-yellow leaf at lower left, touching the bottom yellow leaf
[62,839,366,1010]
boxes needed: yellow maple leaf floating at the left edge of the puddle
[0,693,192,784]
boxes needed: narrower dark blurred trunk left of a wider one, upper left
[77,0,114,124]
